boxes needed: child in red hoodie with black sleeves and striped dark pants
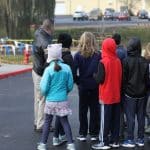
[92,38,122,149]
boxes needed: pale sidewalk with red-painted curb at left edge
[0,64,32,79]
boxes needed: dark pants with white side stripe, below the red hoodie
[99,103,120,145]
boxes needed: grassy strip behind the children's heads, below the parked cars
[54,25,150,47]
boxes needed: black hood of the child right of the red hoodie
[127,37,141,56]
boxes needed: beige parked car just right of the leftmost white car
[88,8,103,20]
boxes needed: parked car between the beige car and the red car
[104,8,115,20]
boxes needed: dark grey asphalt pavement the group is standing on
[0,73,150,150]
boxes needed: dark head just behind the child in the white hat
[57,33,72,48]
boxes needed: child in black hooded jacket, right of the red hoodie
[122,37,149,148]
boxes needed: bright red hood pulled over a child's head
[102,38,117,58]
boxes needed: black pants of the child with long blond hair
[79,89,100,136]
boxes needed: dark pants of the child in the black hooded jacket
[124,96,145,140]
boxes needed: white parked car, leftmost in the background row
[73,11,88,20]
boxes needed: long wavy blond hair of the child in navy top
[78,32,98,58]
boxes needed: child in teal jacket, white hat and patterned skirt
[37,44,75,150]
